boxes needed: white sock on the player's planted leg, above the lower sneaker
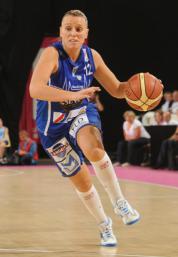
[76,185,108,224]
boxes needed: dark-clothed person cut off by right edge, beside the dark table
[154,127,178,170]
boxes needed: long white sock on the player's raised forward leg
[91,153,124,206]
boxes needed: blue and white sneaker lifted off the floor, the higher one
[114,199,140,225]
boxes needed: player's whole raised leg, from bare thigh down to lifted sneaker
[77,125,140,225]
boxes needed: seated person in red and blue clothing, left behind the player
[14,130,38,165]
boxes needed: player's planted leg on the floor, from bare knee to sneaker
[70,164,117,246]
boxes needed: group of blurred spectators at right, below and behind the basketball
[115,90,178,170]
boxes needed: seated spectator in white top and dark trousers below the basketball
[115,111,150,166]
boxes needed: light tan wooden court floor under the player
[0,164,178,257]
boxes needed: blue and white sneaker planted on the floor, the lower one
[99,217,117,247]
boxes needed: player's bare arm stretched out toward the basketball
[92,49,128,98]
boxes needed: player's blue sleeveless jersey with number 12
[36,42,95,136]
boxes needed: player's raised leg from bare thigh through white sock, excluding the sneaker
[77,126,123,205]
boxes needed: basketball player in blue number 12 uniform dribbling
[30,10,140,246]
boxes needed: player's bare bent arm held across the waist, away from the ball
[30,47,100,102]
